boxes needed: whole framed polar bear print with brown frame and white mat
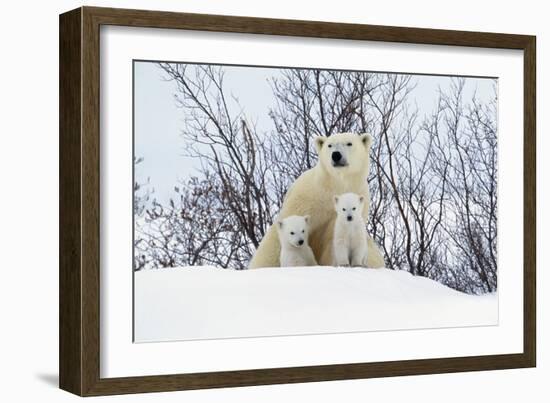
[60,7,536,396]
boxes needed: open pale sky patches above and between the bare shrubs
[134,62,494,207]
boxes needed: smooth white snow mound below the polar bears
[134,267,498,342]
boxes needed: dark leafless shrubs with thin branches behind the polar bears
[135,63,497,293]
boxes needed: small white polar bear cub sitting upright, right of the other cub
[332,193,368,267]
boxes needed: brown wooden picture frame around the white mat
[59,7,536,396]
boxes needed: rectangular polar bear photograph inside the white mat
[133,59,500,343]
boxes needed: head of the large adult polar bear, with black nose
[315,133,372,175]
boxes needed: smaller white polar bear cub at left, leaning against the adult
[277,215,317,267]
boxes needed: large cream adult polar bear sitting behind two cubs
[249,133,384,269]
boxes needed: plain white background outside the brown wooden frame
[0,0,550,402]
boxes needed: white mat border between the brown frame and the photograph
[100,27,523,377]
